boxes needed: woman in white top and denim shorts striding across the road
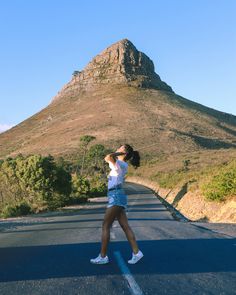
[90,144,143,264]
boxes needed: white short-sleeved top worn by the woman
[108,160,128,189]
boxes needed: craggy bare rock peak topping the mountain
[54,39,173,100]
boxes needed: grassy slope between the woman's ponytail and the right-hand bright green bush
[129,149,236,191]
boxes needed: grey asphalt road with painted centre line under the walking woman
[0,183,236,295]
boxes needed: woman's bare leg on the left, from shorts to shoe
[100,206,123,257]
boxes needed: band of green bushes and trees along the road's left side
[0,135,107,217]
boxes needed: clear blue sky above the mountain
[0,0,236,131]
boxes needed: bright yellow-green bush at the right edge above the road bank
[202,161,236,201]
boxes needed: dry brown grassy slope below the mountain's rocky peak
[0,85,236,163]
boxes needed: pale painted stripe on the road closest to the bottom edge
[114,251,143,295]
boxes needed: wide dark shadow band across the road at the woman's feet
[0,239,236,282]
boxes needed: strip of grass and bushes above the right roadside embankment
[129,149,236,201]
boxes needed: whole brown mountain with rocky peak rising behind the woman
[0,39,236,158]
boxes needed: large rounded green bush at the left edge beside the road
[0,155,71,214]
